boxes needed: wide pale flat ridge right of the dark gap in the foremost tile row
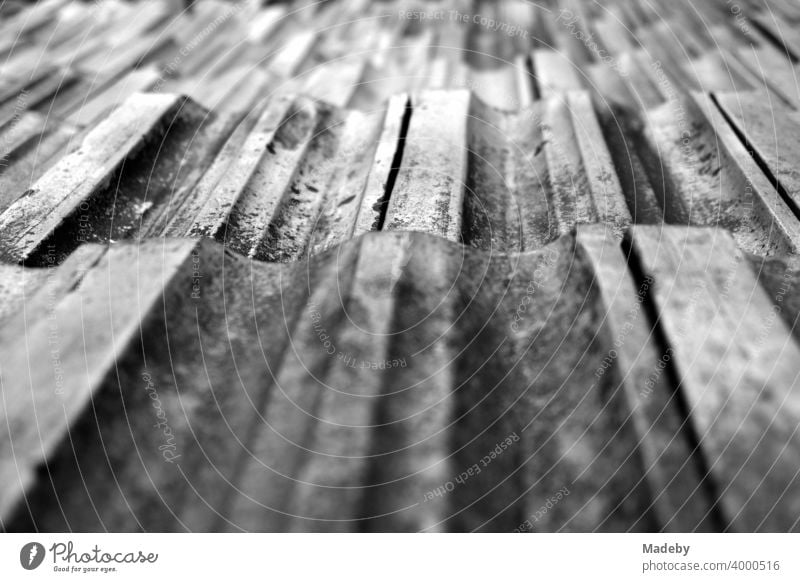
[632,227,800,531]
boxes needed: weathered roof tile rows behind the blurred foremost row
[0,1,800,264]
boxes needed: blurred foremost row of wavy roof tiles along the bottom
[2,227,798,531]
